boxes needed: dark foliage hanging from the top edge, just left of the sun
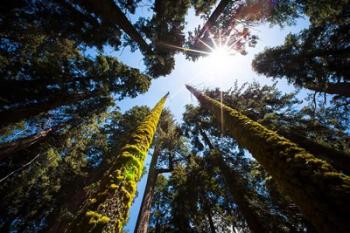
[137,0,190,77]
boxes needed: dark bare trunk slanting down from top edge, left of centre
[79,0,152,54]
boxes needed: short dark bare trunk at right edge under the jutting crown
[303,82,350,97]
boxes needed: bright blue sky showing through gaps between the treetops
[106,5,308,232]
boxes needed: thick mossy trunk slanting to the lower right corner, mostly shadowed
[187,86,350,233]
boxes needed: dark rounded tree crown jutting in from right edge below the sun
[252,24,350,97]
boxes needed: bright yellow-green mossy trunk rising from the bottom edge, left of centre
[65,95,167,233]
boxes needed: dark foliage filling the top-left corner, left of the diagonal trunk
[0,0,121,49]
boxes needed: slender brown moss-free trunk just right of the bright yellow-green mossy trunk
[134,144,160,233]
